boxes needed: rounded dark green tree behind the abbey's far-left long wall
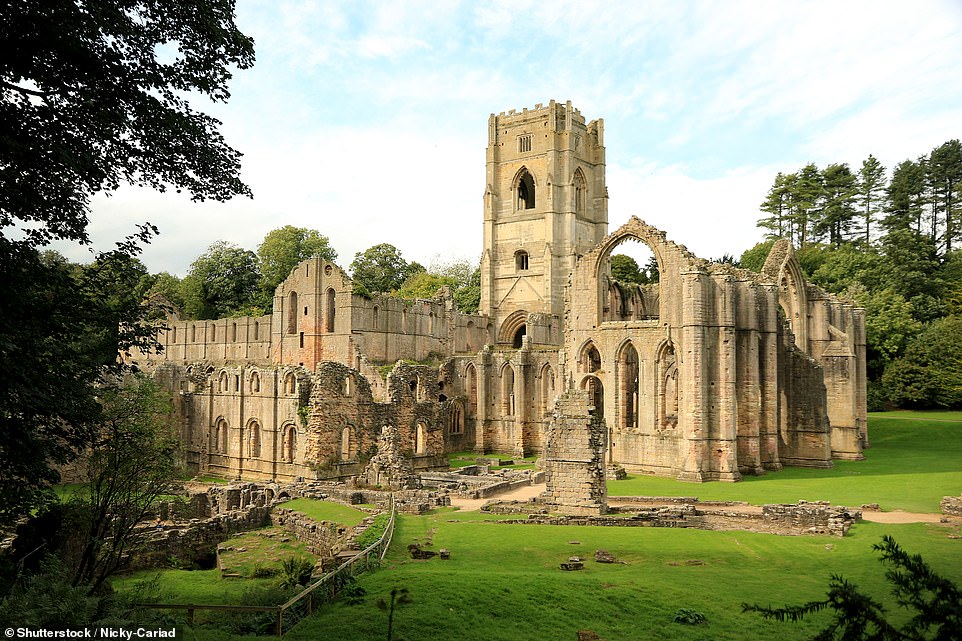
[183,240,260,320]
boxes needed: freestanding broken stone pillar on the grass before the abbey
[541,390,608,516]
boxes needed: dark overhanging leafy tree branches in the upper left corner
[0,0,254,244]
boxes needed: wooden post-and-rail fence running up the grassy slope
[140,496,397,637]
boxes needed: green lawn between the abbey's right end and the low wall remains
[608,412,962,512]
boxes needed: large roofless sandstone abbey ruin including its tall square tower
[134,101,868,483]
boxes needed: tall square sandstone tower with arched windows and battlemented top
[480,100,608,340]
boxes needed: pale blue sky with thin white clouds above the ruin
[61,0,962,275]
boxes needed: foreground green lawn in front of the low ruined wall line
[287,511,962,641]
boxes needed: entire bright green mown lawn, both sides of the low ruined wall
[127,414,962,641]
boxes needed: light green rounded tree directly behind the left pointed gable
[257,225,337,309]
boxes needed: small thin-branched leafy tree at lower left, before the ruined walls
[63,375,180,593]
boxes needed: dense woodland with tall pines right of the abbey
[738,140,962,410]
